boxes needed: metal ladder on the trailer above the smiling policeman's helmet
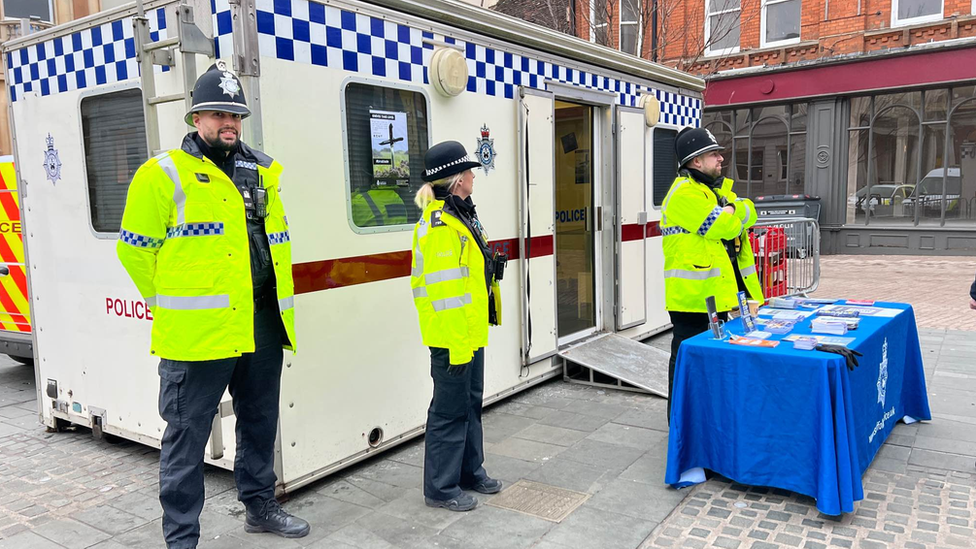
[132,0,214,157]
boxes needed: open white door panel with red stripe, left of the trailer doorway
[518,88,557,364]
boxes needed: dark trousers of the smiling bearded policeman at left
[159,305,283,549]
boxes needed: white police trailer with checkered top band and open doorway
[3,0,703,490]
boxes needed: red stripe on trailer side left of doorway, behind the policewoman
[292,235,553,294]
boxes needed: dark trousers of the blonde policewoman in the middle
[424,347,488,501]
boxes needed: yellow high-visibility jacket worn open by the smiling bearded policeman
[116,137,295,361]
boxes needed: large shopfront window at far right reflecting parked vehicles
[847,86,976,228]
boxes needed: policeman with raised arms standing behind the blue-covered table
[661,128,763,423]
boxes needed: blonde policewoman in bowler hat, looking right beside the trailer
[410,141,505,511]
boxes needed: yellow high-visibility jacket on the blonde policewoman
[410,200,501,364]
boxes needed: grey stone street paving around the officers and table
[0,257,976,549]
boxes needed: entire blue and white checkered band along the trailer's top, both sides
[7,0,702,126]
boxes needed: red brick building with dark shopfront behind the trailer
[504,0,976,255]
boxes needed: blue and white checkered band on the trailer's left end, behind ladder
[7,8,169,101]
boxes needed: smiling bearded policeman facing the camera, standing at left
[117,62,309,549]
